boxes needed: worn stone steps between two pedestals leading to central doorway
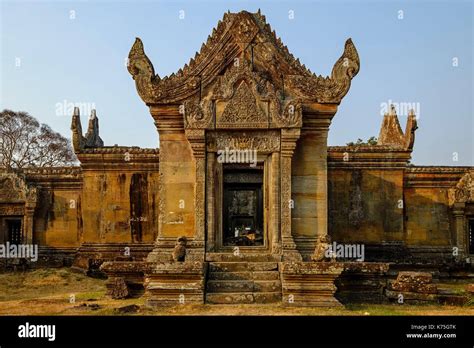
[206,261,282,304]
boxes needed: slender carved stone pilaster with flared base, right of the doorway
[280,129,302,261]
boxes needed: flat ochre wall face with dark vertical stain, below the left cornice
[82,171,159,243]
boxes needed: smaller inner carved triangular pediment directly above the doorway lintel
[183,57,302,129]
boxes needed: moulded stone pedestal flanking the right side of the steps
[281,262,344,307]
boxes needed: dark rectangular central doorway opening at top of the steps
[222,166,264,246]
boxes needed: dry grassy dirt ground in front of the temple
[0,268,474,316]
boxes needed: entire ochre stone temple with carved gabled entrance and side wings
[0,11,474,306]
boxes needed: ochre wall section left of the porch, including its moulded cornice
[79,148,159,244]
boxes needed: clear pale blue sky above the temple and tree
[0,0,474,165]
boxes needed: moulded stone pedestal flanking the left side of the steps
[145,261,207,306]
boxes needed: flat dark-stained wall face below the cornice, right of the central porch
[328,168,404,243]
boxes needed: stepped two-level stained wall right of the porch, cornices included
[328,147,469,262]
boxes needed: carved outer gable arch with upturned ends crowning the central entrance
[128,11,360,109]
